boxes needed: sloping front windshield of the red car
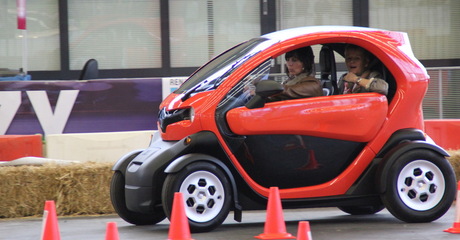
[175,38,272,99]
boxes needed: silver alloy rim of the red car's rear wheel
[397,160,446,211]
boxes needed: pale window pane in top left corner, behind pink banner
[0,0,61,71]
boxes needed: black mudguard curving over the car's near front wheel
[164,153,242,222]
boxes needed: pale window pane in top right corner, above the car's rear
[369,0,460,60]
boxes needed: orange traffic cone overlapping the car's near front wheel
[168,192,193,240]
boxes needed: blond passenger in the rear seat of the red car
[338,44,388,95]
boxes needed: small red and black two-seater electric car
[111,26,456,232]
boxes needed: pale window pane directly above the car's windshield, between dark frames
[169,0,260,67]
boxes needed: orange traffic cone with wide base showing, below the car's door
[254,187,295,239]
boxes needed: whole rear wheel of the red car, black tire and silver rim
[382,149,456,222]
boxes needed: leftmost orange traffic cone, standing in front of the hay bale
[40,200,61,240]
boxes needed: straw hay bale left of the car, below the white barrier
[0,162,114,218]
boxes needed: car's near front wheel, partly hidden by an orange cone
[161,162,232,233]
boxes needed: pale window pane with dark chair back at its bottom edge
[68,0,161,70]
